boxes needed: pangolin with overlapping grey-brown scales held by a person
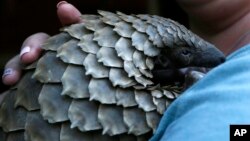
[0,11,224,141]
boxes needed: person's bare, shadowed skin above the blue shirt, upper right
[177,0,250,55]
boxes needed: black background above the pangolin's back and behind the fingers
[0,0,187,93]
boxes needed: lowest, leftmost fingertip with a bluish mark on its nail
[2,55,22,85]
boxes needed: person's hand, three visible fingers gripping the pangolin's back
[2,1,81,85]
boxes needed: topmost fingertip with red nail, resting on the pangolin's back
[57,1,81,25]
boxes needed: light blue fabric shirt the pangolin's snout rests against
[151,45,250,141]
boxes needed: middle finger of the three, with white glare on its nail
[20,33,49,64]
